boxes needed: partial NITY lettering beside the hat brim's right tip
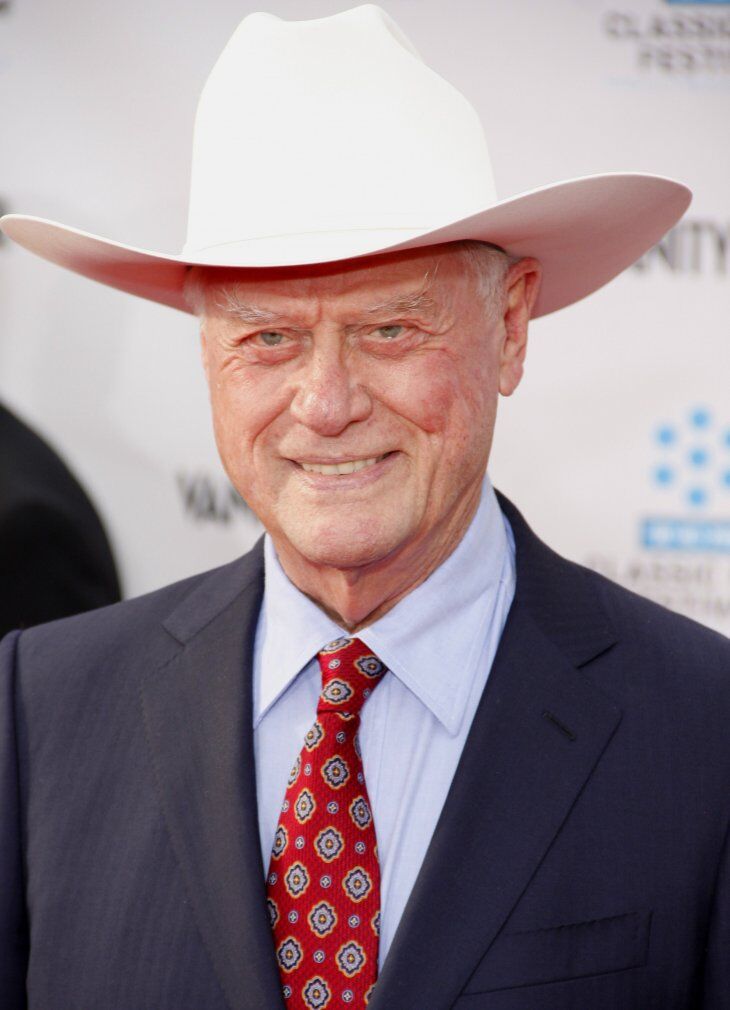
[632,217,730,277]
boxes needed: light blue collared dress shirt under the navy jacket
[253,478,515,967]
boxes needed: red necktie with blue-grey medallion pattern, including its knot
[267,638,387,1010]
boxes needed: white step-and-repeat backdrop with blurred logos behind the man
[0,0,730,633]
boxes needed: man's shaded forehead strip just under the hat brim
[202,245,466,312]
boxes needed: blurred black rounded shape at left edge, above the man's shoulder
[0,404,120,636]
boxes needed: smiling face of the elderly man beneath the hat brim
[203,246,525,569]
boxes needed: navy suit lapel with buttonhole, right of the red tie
[370,501,620,1010]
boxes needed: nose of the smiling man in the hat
[290,339,373,437]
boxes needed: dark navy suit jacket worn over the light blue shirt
[0,502,730,1010]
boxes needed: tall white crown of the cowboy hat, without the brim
[183,4,497,263]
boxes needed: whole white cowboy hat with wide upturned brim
[0,4,691,316]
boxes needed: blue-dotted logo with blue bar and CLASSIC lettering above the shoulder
[587,405,730,634]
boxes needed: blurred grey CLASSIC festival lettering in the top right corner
[602,0,730,74]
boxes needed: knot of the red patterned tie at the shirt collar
[317,638,388,719]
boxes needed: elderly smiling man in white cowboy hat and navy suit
[0,6,730,1010]
